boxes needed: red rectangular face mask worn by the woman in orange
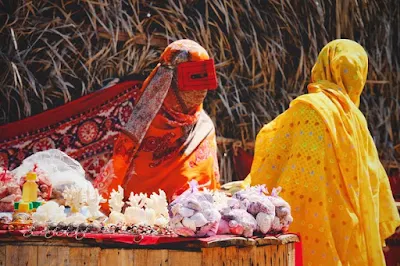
[177,59,218,91]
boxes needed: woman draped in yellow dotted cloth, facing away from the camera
[245,40,400,266]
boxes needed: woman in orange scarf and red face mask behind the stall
[94,40,219,205]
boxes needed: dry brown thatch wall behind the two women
[0,0,400,181]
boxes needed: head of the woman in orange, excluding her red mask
[160,40,209,114]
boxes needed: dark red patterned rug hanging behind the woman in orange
[0,77,142,181]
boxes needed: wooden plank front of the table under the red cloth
[0,234,299,266]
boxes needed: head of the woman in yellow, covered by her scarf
[311,39,368,106]
